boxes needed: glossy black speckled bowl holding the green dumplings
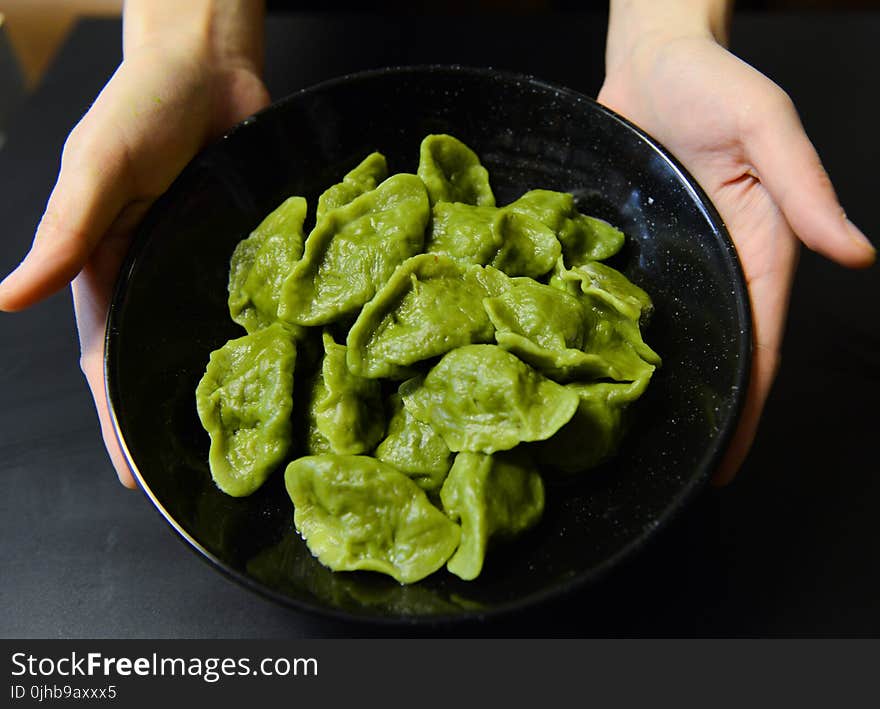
[105,67,751,621]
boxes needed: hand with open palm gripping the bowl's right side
[598,16,875,484]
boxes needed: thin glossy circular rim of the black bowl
[103,64,753,627]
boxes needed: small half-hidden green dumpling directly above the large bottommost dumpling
[374,394,452,491]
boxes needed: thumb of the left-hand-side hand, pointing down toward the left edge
[0,112,132,311]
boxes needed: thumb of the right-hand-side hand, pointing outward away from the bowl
[745,94,875,268]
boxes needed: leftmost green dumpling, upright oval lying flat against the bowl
[196,323,296,497]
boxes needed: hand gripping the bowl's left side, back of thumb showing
[0,0,269,487]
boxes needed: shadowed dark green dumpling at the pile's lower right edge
[536,373,651,474]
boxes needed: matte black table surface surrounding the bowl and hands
[0,14,880,638]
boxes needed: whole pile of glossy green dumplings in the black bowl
[196,135,660,583]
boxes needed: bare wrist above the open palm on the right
[605,0,733,73]
